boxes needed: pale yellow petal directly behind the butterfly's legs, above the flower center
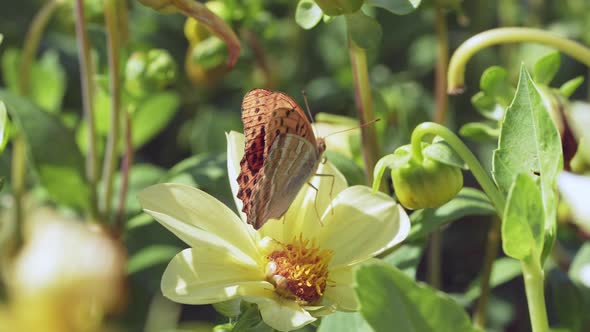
[259,161,347,243]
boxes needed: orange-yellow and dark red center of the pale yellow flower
[267,235,334,305]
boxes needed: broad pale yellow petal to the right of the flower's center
[317,186,410,269]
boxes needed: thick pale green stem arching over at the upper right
[448,28,590,94]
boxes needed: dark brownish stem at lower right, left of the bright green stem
[473,216,502,330]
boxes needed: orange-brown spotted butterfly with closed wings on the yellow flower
[237,89,326,229]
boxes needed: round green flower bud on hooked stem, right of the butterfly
[390,145,463,209]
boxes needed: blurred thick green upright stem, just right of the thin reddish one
[101,0,121,220]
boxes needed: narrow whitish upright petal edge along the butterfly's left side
[225,131,246,221]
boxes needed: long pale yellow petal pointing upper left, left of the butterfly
[139,183,260,261]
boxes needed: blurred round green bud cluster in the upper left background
[125,49,176,96]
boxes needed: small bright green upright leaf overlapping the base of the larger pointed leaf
[502,173,544,260]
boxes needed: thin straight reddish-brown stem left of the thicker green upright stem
[74,0,98,220]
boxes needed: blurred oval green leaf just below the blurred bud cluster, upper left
[132,92,180,148]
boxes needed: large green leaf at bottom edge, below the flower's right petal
[355,263,475,332]
